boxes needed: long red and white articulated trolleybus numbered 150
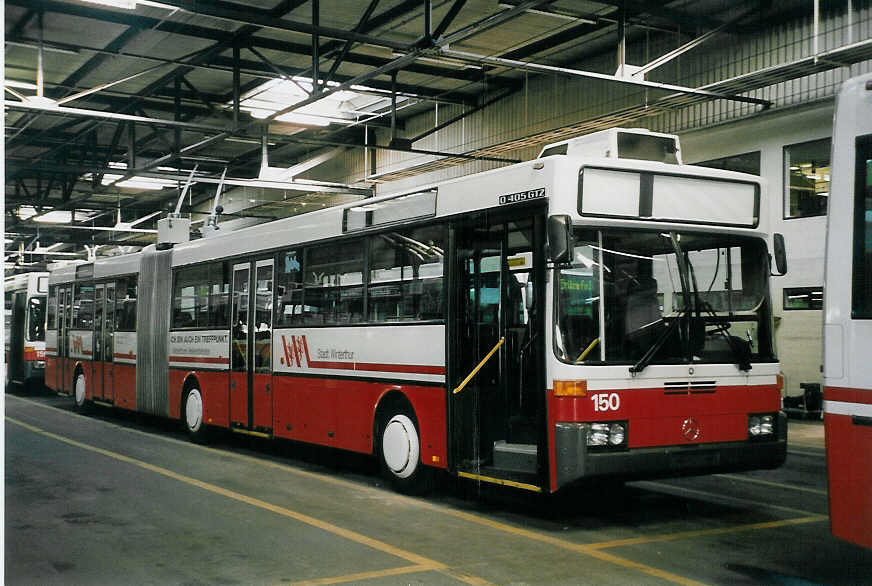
[48,129,786,492]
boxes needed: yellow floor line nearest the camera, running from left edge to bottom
[6,416,481,584]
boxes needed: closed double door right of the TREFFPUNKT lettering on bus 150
[230,259,273,434]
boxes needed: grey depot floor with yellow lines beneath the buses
[4,393,872,585]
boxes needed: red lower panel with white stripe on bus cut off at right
[824,388,872,548]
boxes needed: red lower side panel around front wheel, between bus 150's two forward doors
[273,376,447,468]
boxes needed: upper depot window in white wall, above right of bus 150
[784,138,832,219]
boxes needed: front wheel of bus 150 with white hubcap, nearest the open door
[376,404,433,494]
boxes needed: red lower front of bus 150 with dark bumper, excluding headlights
[547,385,787,490]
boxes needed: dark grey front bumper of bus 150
[554,413,787,488]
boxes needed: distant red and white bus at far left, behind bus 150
[3,272,48,390]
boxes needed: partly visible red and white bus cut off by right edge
[824,75,872,548]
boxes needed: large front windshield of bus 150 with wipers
[554,229,775,372]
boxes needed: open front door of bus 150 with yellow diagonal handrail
[449,210,546,490]
